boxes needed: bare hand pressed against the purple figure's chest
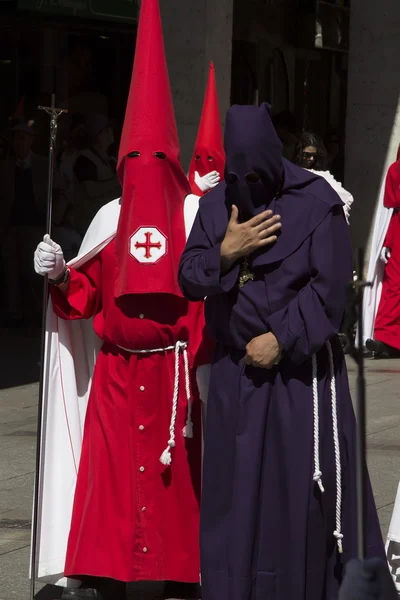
[221,205,282,270]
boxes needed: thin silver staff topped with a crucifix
[29,94,68,600]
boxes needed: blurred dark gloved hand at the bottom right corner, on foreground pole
[339,558,398,600]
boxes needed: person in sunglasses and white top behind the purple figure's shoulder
[293,131,354,222]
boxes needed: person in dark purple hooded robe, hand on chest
[180,105,385,600]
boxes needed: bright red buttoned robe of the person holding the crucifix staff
[52,241,206,582]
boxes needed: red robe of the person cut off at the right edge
[374,161,400,350]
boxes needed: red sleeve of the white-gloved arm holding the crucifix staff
[51,255,101,321]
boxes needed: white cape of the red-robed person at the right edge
[363,180,393,345]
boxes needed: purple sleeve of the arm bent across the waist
[268,207,353,364]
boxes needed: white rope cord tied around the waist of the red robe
[118,342,193,466]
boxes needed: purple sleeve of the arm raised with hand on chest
[179,211,239,300]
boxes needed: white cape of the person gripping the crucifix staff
[35,195,209,587]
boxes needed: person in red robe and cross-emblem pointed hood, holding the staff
[35,0,208,600]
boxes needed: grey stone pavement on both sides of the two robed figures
[0,330,400,600]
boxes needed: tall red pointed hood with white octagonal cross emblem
[115,0,190,297]
